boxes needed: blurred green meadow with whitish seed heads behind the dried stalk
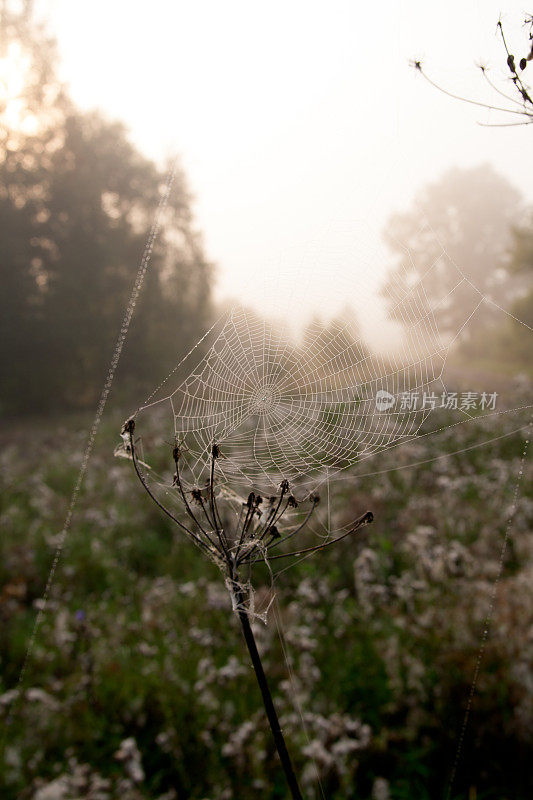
[0,396,533,800]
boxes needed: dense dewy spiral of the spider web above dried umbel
[129,228,494,491]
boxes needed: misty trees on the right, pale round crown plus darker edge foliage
[384,164,533,370]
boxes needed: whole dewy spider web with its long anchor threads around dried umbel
[119,220,530,796]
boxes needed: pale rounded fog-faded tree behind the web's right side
[384,164,521,335]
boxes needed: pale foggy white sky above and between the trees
[37,0,533,340]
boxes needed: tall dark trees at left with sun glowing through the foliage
[0,1,212,411]
